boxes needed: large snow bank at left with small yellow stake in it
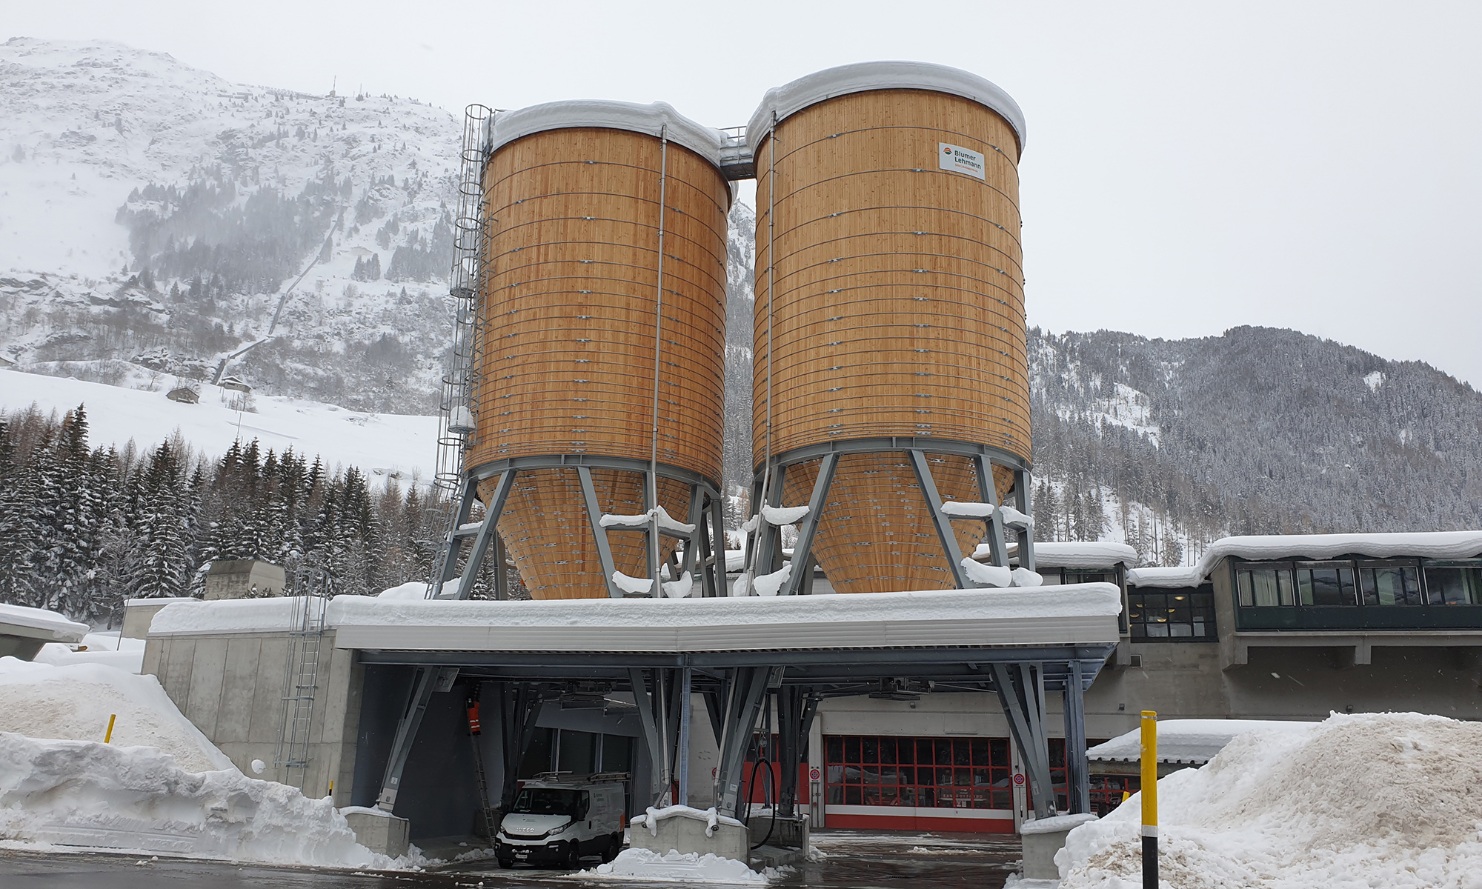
[0,658,422,868]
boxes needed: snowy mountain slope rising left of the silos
[0,37,461,413]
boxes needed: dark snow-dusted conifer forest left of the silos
[0,406,488,627]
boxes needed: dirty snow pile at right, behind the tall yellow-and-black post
[1055,714,1482,889]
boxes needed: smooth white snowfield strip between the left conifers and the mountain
[0,370,437,489]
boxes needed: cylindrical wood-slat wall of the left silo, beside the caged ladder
[465,127,731,480]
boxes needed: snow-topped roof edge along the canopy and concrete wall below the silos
[150,584,1122,653]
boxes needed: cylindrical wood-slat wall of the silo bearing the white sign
[753,90,1030,464]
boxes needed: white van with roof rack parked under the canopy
[494,772,628,868]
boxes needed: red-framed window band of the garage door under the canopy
[824,735,1014,809]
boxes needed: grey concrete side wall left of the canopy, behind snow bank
[142,633,362,805]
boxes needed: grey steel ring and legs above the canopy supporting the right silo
[747,436,1034,596]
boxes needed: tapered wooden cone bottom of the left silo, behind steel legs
[479,468,689,599]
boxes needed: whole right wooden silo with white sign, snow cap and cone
[747,62,1030,591]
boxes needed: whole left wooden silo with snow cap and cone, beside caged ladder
[464,102,731,599]
